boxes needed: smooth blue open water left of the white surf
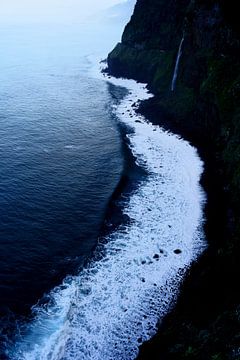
[0,13,133,352]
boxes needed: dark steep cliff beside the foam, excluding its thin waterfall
[108,0,240,360]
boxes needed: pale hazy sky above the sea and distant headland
[0,0,126,23]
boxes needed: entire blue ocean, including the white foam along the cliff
[0,1,205,360]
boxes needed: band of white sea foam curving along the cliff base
[11,70,205,360]
